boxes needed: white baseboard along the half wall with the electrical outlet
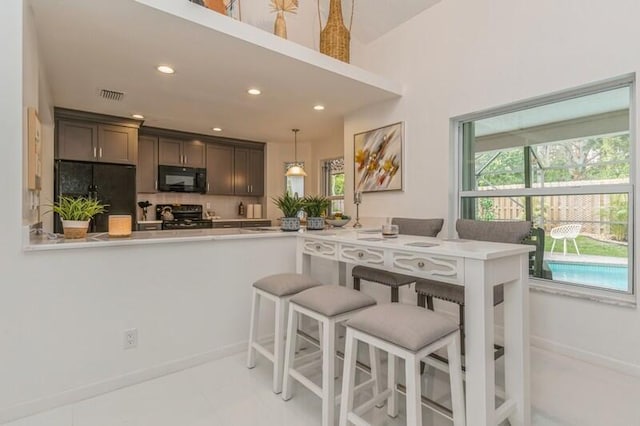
[0,342,247,424]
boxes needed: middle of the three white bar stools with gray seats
[282,285,379,426]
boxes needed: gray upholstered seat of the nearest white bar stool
[347,303,458,352]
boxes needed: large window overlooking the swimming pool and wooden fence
[457,78,634,295]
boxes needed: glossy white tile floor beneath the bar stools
[6,349,640,426]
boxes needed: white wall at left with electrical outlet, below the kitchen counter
[0,0,295,423]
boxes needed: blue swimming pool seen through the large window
[547,261,629,291]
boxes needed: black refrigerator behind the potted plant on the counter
[54,160,136,233]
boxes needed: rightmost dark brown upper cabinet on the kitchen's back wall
[234,148,264,197]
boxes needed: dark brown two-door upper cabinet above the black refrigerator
[55,108,140,165]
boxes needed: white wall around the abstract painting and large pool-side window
[344,0,640,373]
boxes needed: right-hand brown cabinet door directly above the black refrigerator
[98,124,138,165]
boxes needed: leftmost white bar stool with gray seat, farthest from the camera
[247,273,322,393]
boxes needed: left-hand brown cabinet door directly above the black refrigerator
[56,120,98,161]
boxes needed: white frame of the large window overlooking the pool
[449,74,640,307]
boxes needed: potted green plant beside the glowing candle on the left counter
[50,195,107,239]
